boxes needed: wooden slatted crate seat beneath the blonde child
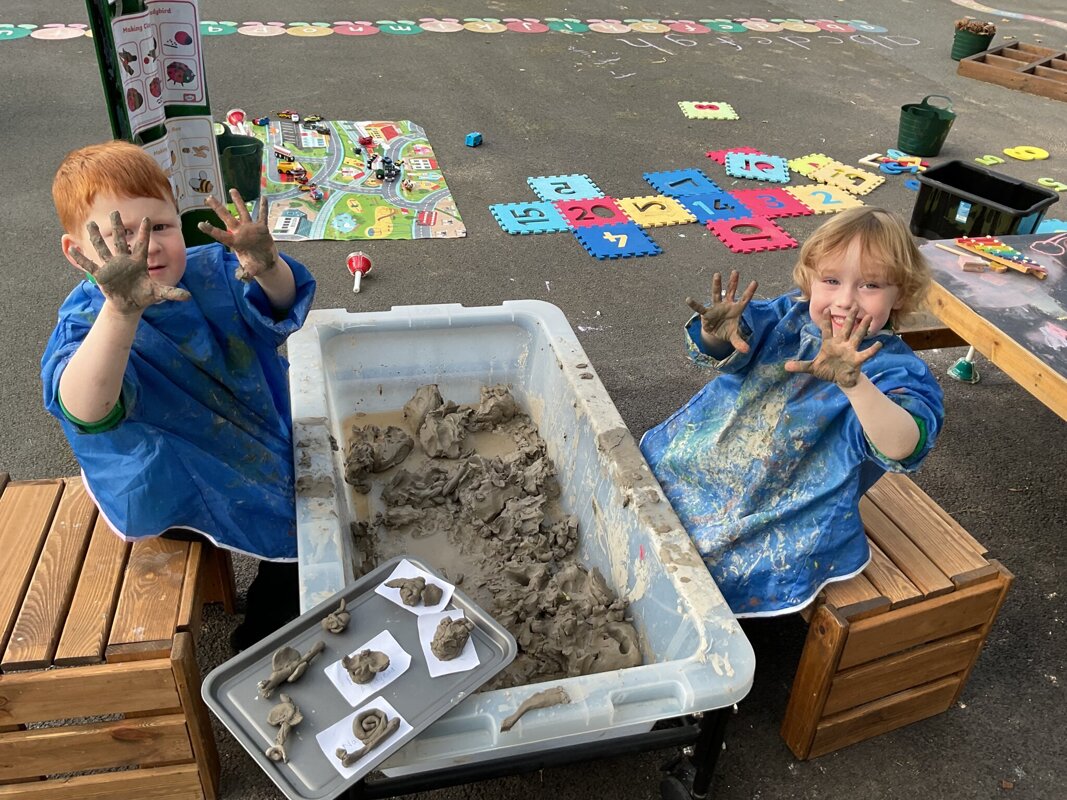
[781,475,1013,759]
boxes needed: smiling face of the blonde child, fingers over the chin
[808,240,903,334]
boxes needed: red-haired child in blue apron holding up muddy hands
[42,141,315,649]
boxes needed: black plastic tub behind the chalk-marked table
[910,161,1058,239]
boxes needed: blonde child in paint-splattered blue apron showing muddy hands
[641,207,943,617]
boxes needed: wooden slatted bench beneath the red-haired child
[0,475,235,800]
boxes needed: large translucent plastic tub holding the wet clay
[288,301,754,774]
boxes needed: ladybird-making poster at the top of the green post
[111,0,209,133]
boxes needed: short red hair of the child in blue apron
[52,140,176,236]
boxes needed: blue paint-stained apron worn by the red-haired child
[42,244,315,559]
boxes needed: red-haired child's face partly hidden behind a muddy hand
[73,196,186,286]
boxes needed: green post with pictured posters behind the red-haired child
[85,0,225,245]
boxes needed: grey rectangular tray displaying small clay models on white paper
[202,557,516,800]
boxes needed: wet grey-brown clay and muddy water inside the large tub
[343,384,641,689]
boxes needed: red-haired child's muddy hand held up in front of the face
[70,211,189,314]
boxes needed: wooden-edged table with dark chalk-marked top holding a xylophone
[921,234,1067,419]
